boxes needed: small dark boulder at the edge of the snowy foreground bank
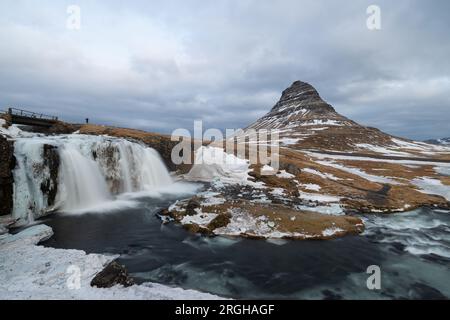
[91,261,134,288]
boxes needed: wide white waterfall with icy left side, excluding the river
[13,134,172,224]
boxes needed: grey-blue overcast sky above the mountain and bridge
[0,0,450,139]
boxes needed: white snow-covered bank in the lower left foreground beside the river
[0,225,220,300]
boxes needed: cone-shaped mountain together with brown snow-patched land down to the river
[166,81,450,239]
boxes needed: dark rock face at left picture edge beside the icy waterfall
[0,135,16,215]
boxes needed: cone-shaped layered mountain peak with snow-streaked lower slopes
[246,81,446,157]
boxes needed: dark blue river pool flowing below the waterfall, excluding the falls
[43,195,450,299]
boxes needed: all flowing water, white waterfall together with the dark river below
[6,129,450,299]
